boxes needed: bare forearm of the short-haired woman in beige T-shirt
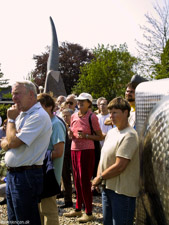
[92,157,130,186]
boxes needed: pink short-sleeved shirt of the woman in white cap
[70,111,100,150]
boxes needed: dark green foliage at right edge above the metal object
[155,40,169,79]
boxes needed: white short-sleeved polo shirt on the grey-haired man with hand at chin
[5,102,52,167]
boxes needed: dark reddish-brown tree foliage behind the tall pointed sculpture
[28,42,93,94]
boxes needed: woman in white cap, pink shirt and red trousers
[63,93,103,222]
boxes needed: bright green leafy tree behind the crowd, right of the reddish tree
[73,44,137,100]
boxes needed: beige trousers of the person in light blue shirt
[39,196,59,225]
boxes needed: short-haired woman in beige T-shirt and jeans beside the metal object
[92,97,139,225]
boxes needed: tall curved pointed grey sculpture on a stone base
[44,17,67,97]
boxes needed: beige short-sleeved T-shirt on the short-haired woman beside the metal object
[100,127,140,197]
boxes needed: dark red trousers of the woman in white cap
[71,149,95,213]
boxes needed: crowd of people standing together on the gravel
[0,81,139,225]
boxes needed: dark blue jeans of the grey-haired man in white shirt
[6,168,43,225]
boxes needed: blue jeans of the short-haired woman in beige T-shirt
[102,189,136,225]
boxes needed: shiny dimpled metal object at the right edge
[136,79,169,225]
